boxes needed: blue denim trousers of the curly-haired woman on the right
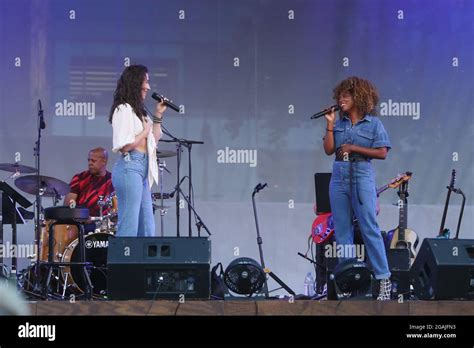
[329,161,390,279]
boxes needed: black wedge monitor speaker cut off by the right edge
[410,238,474,300]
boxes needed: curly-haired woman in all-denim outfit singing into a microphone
[323,77,391,301]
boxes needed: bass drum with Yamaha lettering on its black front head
[61,233,113,298]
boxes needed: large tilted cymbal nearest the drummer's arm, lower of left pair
[15,175,70,197]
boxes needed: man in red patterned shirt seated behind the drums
[64,147,114,232]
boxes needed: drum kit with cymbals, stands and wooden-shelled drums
[0,147,181,299]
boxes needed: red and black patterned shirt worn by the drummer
[69,170,114,216]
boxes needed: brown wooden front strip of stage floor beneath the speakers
[28,300,474,316]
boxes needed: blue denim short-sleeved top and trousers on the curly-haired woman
[329,115,391,279]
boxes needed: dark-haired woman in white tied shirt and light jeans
[109,65,166,237]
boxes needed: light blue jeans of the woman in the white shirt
[112,151,155,237]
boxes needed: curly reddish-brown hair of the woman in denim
[333,76,379,116]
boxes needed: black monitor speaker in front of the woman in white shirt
[107,237,211,300]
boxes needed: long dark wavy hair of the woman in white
[109,65,148,123]
